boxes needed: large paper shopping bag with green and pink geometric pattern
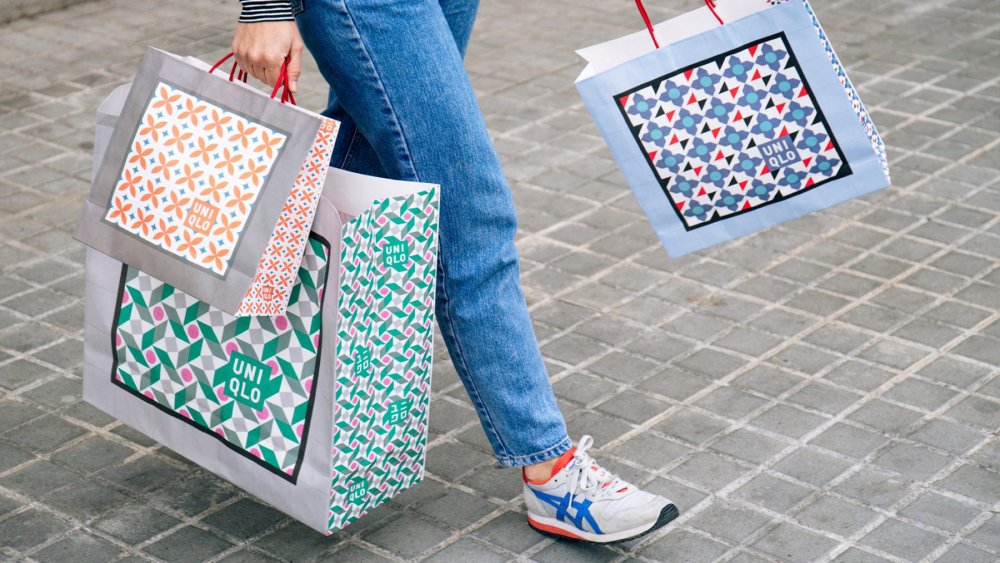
[83,82,438,533]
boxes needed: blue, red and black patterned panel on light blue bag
[616,33,851,231]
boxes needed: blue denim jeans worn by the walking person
[293,0,571,467]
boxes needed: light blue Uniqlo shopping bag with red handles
[576,0,889,256]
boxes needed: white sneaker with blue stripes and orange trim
[521,436,678,543]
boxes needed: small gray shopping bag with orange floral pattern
[76,48,338,315]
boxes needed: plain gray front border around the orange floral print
[74,47,321,314]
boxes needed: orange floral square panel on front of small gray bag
[104,82,288,275]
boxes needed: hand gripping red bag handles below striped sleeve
[233,22,302,93]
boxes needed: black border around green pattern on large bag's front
[111,232,334,485]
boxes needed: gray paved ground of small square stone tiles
[0,0,1000,563]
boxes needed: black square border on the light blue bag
[612,31,854,232]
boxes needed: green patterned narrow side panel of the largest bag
[329,189,438,530]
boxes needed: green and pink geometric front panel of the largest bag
[112,235,329,483]
